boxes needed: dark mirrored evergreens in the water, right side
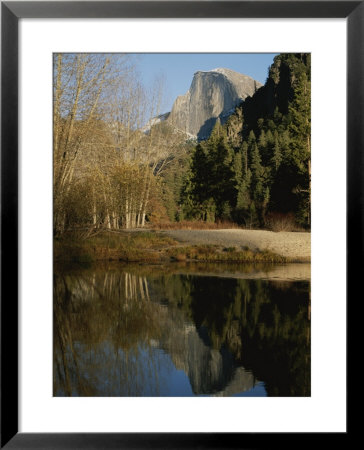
[152,275,311,396]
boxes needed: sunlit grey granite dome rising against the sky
[168,68,262,139]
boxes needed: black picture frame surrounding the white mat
[1,1,356,449]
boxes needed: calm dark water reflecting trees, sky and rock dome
[53,264,311,397]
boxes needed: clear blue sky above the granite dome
[135,53,276,113]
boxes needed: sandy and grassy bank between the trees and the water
[54,229,311,263]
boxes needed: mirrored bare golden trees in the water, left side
[54,272,170,396]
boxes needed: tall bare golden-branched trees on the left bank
[53,54,189,237]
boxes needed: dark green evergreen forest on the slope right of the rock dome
[163,53,311,229]
